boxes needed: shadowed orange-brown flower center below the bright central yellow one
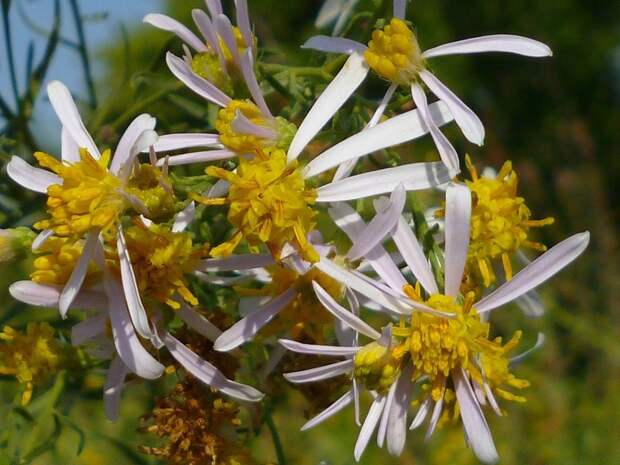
[237,265,344,344]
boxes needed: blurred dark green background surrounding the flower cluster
[0,0,620,465]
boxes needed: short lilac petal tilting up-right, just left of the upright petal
[347,184,407,261]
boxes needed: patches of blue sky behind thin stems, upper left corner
[0,0,162,147]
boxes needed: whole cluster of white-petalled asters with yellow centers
[0,0,589,464]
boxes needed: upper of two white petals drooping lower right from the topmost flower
[420,70,484,145]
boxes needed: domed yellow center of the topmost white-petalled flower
[364,18,426,86]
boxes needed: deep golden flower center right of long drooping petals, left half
[110,222,213,310]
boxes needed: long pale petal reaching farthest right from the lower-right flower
[475,232,590,313]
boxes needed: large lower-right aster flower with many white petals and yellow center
[288,184,589,463]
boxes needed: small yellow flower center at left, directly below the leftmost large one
[30,236,97,286]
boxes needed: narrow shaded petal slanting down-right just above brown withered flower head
[163,333,263,402]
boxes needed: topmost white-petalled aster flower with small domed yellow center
[300,0,552,170]
